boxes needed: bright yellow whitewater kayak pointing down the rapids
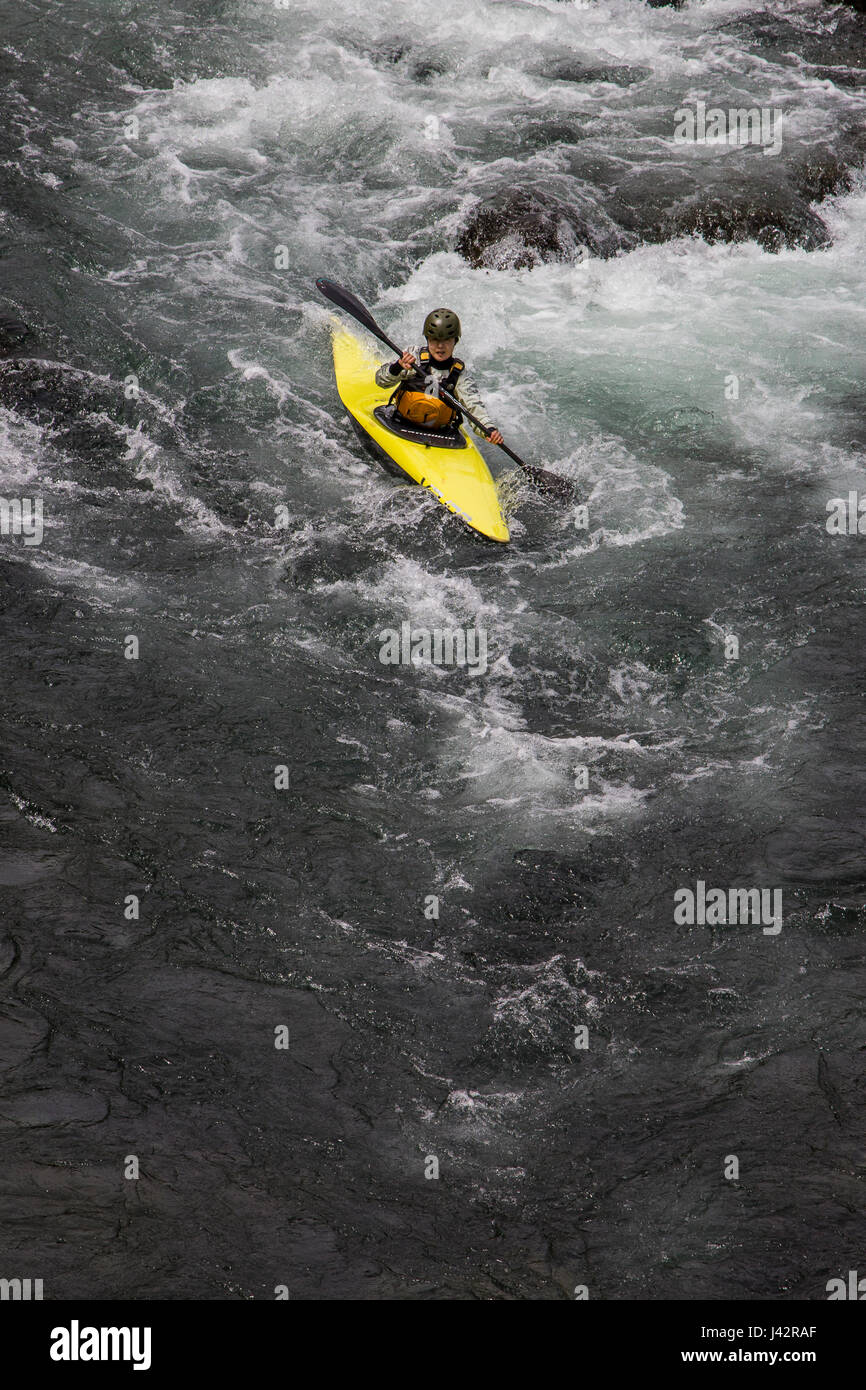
[334,325,509,541]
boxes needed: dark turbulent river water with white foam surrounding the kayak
[0,0,866,1300]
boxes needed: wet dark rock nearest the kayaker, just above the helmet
[456,189,634,270]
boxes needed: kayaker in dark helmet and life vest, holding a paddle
[375,309,503,443]
